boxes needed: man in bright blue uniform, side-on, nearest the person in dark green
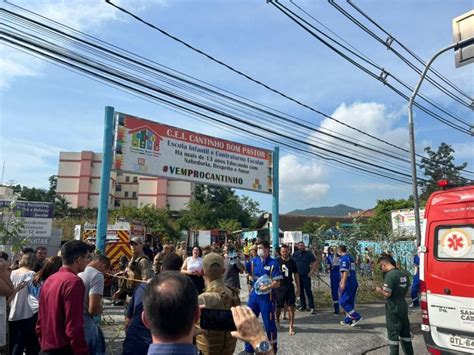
[339,245,362,327]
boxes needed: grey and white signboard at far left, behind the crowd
[0,200,53,245]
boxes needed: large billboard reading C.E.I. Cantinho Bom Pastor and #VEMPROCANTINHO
[112,113,273,193]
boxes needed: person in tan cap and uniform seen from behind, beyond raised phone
[196,253,240,355]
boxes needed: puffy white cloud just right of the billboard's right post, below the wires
[280,154,329,209]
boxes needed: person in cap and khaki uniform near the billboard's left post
[113,237,153,299]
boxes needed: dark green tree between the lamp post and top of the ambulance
[420,143,467,201]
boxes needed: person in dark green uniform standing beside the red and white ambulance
[376,256,413,355]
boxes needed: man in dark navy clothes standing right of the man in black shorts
[292,242,318,314]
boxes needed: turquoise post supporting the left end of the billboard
[96,106,114,253]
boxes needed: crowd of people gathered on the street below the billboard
[0,237,412,355]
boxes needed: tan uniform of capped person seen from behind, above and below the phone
[196,278,240,355]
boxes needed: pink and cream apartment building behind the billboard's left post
[56,151,194,211]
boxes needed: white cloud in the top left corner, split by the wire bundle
[0,0,161,90]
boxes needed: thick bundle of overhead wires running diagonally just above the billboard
[0,0,470,183]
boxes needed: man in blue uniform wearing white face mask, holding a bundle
[245,240,283,353]
